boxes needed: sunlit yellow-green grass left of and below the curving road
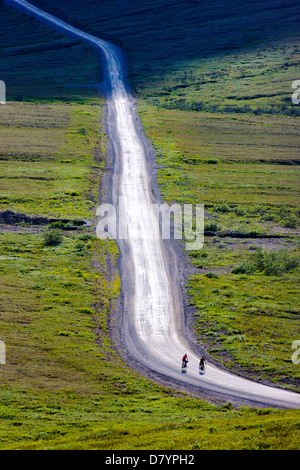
[0,102,298,450]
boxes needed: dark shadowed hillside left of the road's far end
[0,4,101,101]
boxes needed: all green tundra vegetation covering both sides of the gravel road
[0,0,300,450]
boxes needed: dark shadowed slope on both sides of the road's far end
[0,0,300,101]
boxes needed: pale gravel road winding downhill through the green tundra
[5,0,300,408]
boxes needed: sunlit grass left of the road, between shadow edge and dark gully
[0,102,104,219]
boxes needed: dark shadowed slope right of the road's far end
[27,0,300,55]
